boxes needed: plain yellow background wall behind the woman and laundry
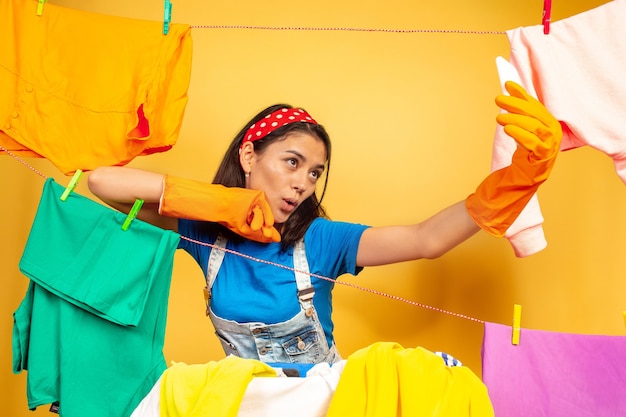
[0,0,626,417]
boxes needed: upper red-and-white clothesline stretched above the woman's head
[190,25,506,35]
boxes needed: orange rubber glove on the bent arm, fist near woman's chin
[159,175,280,243]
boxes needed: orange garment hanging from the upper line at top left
[0,0,192,175]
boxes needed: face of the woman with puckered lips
[246,132,326,224]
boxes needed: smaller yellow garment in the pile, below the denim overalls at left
[160,356,276,417]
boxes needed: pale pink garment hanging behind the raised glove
[492,0,626,257]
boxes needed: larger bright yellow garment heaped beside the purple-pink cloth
[327,342,494,417]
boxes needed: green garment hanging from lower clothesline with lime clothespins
[13,177,180,417]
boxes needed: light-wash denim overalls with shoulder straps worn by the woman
[206,236,341,363]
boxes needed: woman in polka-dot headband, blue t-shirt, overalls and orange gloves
[89,83,562,363]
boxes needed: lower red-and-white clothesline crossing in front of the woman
[0,145,485,324]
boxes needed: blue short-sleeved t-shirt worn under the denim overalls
[178,214,368,343]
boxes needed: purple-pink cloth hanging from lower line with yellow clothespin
[482,323,626,417]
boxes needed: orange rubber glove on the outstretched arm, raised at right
[465,81,563,237]
